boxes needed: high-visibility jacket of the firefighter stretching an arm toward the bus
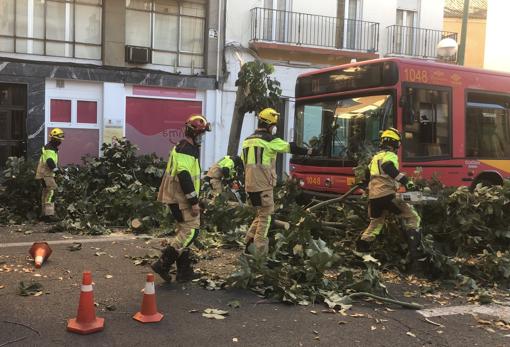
[241,129,308,192]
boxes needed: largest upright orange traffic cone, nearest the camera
[67,271,104,335]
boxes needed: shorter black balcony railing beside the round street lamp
[386,25,457,58]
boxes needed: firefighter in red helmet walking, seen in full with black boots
[151,114,211,282]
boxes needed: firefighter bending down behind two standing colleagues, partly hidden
[203,155,244,195]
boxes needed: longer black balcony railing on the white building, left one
[251,7,379,52]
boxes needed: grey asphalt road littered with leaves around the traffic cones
[0,229,510,347]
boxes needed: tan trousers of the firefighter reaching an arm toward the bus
[245,189,274,254]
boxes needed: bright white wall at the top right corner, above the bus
[480,0,510,72]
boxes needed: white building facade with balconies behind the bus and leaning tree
[214,0,448,173]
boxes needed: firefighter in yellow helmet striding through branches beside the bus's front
[358,128,421,266]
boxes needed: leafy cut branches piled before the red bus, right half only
[230,181,510,306]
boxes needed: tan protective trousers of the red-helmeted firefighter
[169,204,200,251]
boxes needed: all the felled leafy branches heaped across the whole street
[0,141,510,306]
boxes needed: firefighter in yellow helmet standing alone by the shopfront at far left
[35,128,64,222]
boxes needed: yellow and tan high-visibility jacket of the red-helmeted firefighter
[158,140,200,209]
